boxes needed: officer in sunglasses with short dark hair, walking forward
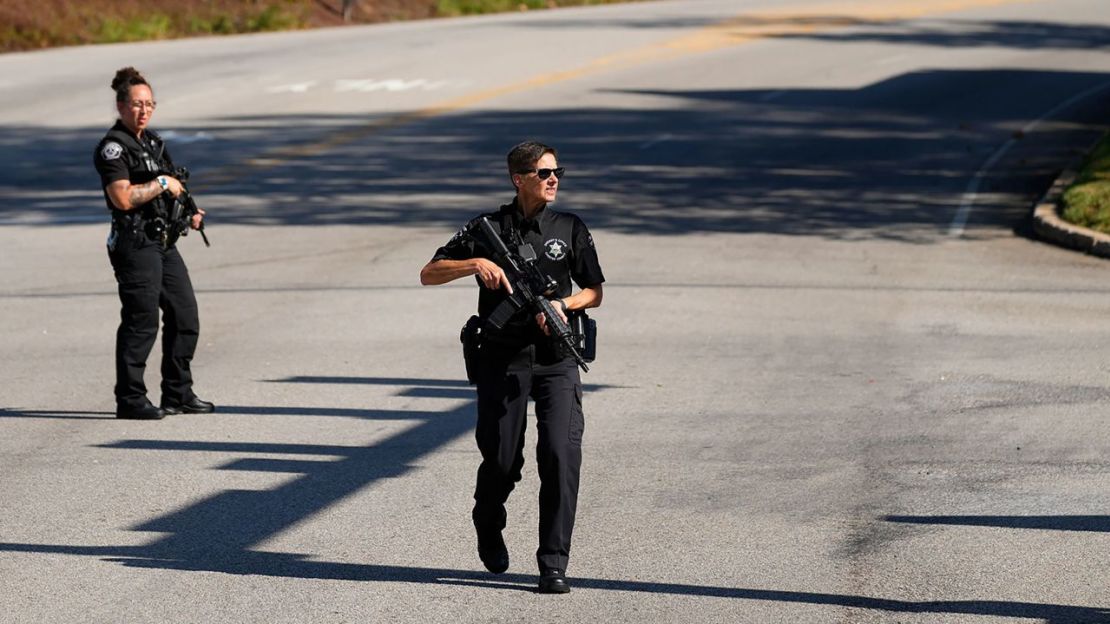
[421,141,605,594]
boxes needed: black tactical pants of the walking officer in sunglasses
[474,344,585,570]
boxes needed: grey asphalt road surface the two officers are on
[0,0,1110,624]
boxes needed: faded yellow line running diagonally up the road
[204,0,1043,187]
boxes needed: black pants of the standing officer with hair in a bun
[108,223,200,407]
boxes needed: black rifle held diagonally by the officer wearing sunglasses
[477,217,589,373]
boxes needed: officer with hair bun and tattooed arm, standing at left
[93,67,215,420]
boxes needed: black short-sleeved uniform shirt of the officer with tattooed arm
[92,121,173,215]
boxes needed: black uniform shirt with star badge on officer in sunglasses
[432,199,605,341]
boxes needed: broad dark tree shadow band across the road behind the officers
[0,70,1110,238]
